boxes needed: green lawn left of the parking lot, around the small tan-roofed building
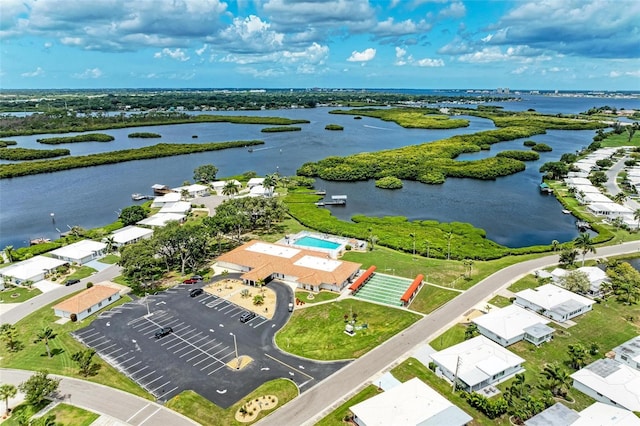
[0,296,152,399]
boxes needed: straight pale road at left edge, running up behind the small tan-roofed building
[2,265,120,324]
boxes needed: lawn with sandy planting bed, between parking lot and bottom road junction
[166,379,298,426]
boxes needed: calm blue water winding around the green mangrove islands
[0,96,638,247]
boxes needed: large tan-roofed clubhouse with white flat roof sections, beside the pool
[217,240,361,292]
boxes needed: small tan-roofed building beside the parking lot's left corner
[53,284,120,321]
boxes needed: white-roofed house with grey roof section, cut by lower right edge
[571,358,640,411]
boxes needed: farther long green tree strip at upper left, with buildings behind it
[0,112,309,137]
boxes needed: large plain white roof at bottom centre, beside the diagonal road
[349,377,473,426]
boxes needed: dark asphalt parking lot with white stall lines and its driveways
[74,282,345,408]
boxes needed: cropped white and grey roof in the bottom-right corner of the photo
[524,402,640,426]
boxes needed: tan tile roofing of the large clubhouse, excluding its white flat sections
[218,240,361,285]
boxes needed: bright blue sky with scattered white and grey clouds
[0,0,640,91]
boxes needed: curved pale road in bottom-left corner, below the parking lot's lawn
[0,369,198,426]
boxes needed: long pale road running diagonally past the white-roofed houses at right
[256,242,640,426]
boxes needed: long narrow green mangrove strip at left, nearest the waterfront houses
[0,140,264,179]
